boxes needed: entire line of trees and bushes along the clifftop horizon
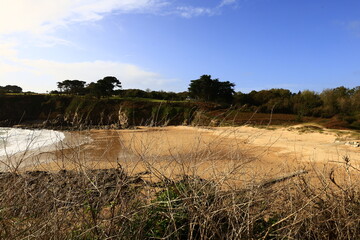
[0,75,360,128]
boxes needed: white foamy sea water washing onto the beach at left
[0,128,65,156]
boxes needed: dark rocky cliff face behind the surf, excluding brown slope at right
[0,95,215,128]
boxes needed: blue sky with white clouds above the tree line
[0,0,360,92]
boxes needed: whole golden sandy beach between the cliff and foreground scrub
[19,125,360,186]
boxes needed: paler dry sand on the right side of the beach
[201,125,360,164]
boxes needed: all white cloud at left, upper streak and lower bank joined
[0,0,233,92]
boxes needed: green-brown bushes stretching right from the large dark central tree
[234,87,360,129]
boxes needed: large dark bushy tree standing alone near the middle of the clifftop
[188,75,235,103]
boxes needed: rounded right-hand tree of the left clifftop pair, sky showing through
[87,76,121,98]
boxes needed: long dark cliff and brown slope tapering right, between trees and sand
[0,94,358,129]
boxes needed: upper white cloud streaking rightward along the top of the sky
[0,0,222,47]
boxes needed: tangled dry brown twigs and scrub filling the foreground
[0,160,360,239]
